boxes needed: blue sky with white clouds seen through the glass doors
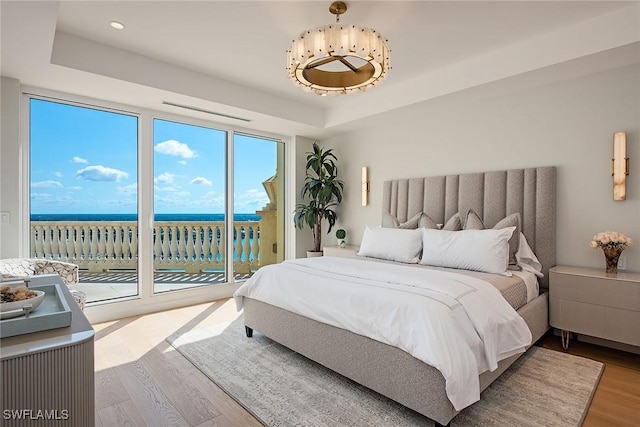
[30,99,277,214]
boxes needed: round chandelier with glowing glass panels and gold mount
[287,1,390,96]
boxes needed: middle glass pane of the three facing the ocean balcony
[153,119,227,292]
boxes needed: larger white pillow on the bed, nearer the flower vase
[420,227,516,276]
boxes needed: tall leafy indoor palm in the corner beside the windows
[293,142,344,254]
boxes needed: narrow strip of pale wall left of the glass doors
[0,77,21,258]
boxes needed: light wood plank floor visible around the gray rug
[94,300,640,427]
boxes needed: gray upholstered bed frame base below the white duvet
[244,293,549,425]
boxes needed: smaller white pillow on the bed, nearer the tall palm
[358,227,422,264]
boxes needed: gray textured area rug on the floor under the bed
[167,319,604,427]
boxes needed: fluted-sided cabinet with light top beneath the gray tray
[0,276,95,427]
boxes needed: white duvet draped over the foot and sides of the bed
[234,257,531,410]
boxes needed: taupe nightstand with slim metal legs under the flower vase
[549,266,640,350]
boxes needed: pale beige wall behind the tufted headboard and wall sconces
[322,64,640,271]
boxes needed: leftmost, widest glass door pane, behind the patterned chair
[29,98,139,302]
